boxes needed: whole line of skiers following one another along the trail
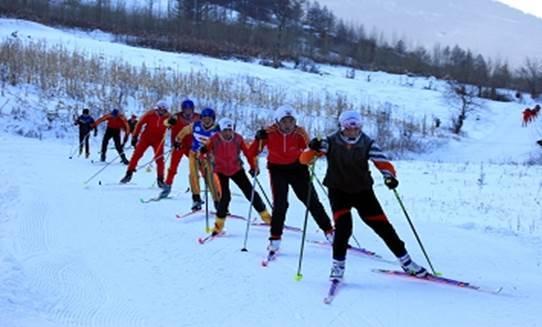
[76,99,428,281]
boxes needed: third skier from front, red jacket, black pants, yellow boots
[204,118,271,236]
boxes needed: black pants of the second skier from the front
[269,164,333,239]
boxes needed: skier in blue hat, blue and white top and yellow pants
[173,108,220,210]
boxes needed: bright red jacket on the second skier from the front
[250,124,309,165]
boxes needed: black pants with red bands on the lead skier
[329,189,406,260]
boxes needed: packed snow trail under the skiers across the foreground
[0,134,542,327]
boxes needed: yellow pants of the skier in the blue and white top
[188,151,222,202]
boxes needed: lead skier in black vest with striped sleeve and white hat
[300,110,428,281]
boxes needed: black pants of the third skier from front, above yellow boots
[216,169,265,218]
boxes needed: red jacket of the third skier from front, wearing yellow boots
[210,132,255,176]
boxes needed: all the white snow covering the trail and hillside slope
[0,19,542,327]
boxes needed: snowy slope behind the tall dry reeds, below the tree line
[0,19,542,163]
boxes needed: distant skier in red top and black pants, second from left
[92,109,130,165]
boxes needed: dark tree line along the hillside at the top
[0,0,542,100]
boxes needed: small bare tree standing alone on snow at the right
[444,80,481,134]
